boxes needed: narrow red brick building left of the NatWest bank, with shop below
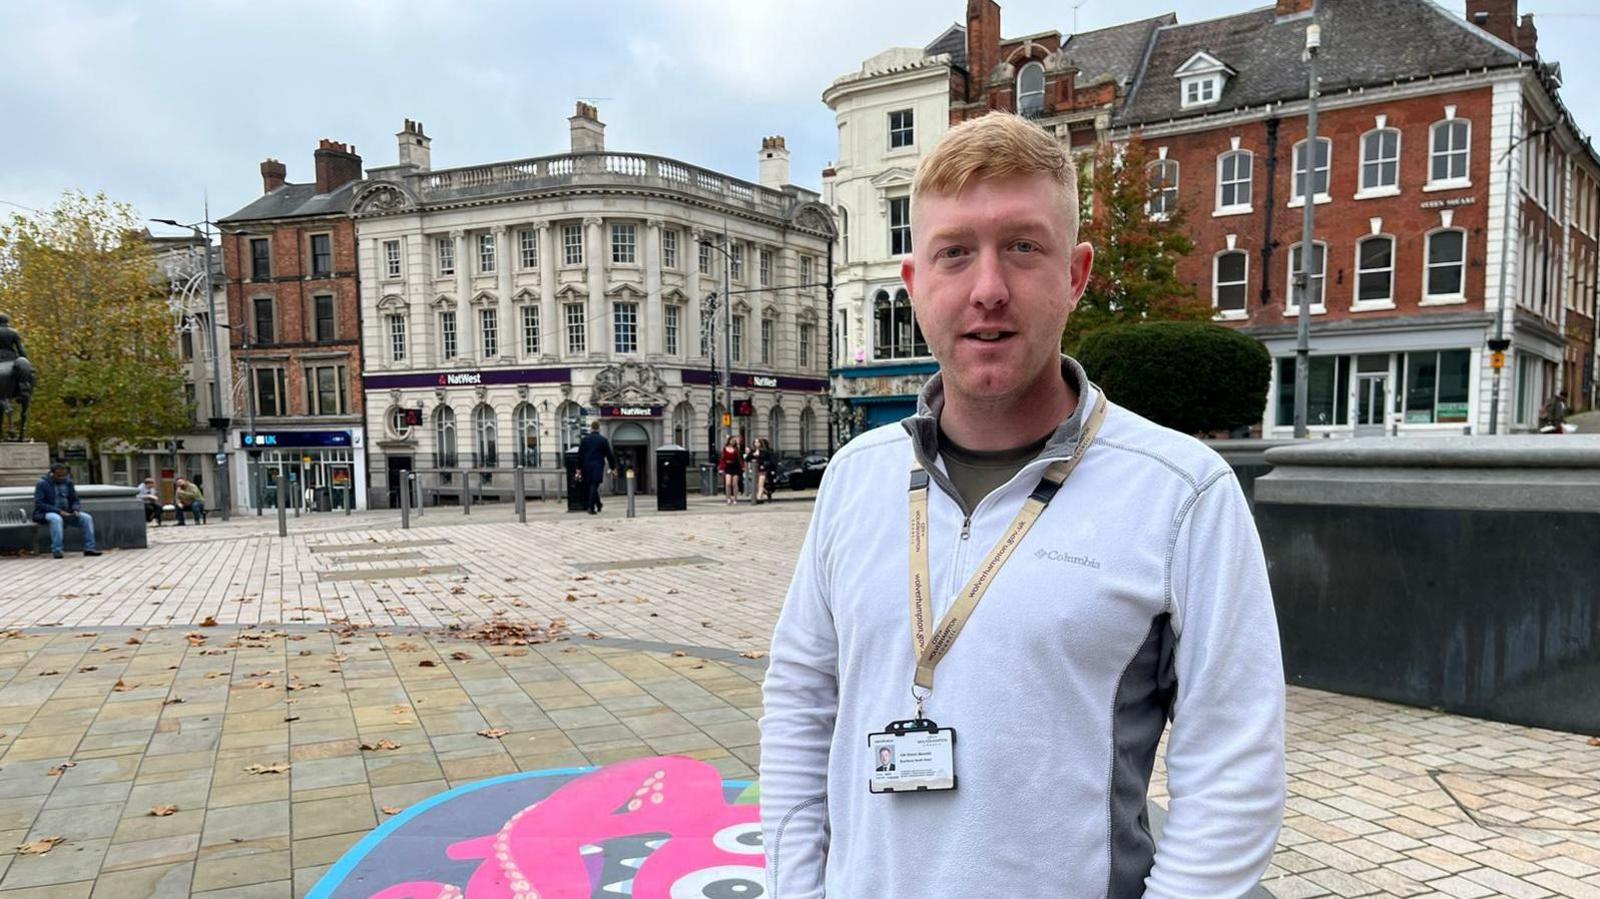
[218,139,366,509]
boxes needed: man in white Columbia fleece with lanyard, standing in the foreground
[760,114,1285,899]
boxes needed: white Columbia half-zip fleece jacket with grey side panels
[760,358,1285,899]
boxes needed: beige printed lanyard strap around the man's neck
[910,397,1107,707]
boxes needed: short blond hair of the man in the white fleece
[910,112,1078,230]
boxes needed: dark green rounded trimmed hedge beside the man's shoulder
[1077,322,1272,434]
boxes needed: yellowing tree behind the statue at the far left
[0,192,187,470]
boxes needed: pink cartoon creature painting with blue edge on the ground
[309,757,765,899]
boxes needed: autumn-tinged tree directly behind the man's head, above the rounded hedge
[1062,139,1214,352]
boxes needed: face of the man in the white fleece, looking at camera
[901,168,1094,400]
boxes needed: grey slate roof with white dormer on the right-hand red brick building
[1117,0,1530,125]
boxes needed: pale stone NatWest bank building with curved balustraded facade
[354,104,834,499]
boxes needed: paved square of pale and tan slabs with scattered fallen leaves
[0,496,1600,897]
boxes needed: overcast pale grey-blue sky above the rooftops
[0,0,1600,232]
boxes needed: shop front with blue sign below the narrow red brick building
[238,427,366,512]
